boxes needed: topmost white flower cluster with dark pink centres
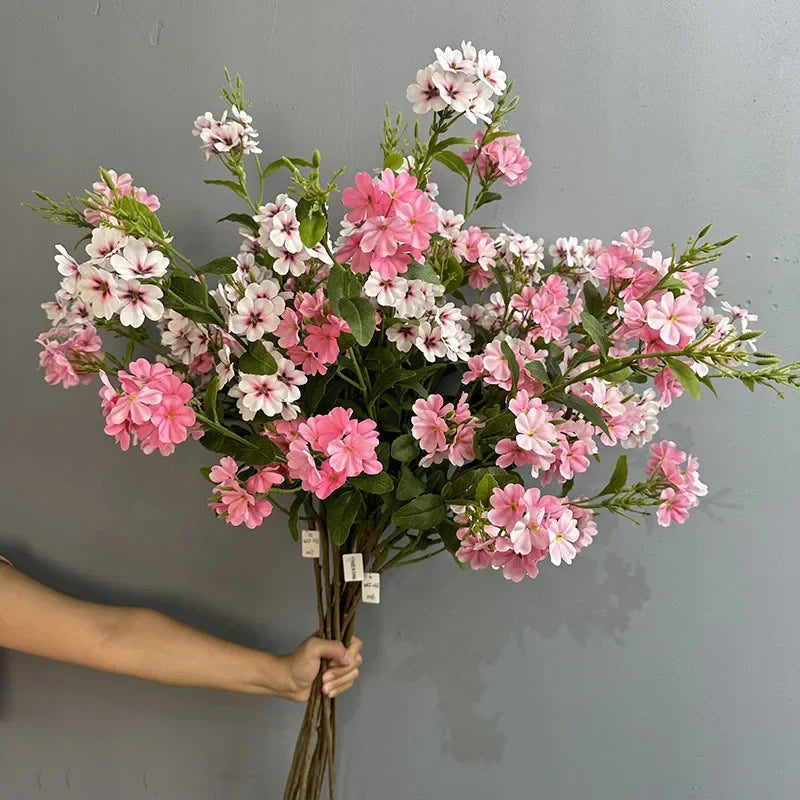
[406,42,506,123]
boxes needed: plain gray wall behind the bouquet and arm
[0,0,800,800]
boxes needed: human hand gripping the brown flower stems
[282,636,363,702]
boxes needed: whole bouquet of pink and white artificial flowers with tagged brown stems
[26,42,800,798]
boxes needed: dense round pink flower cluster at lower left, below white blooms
[100,358,195,455]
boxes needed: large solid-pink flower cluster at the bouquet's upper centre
[336,169,440,280]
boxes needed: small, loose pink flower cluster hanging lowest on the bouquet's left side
[209,456,284,529]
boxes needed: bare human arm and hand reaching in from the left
[0,564,361,701]
